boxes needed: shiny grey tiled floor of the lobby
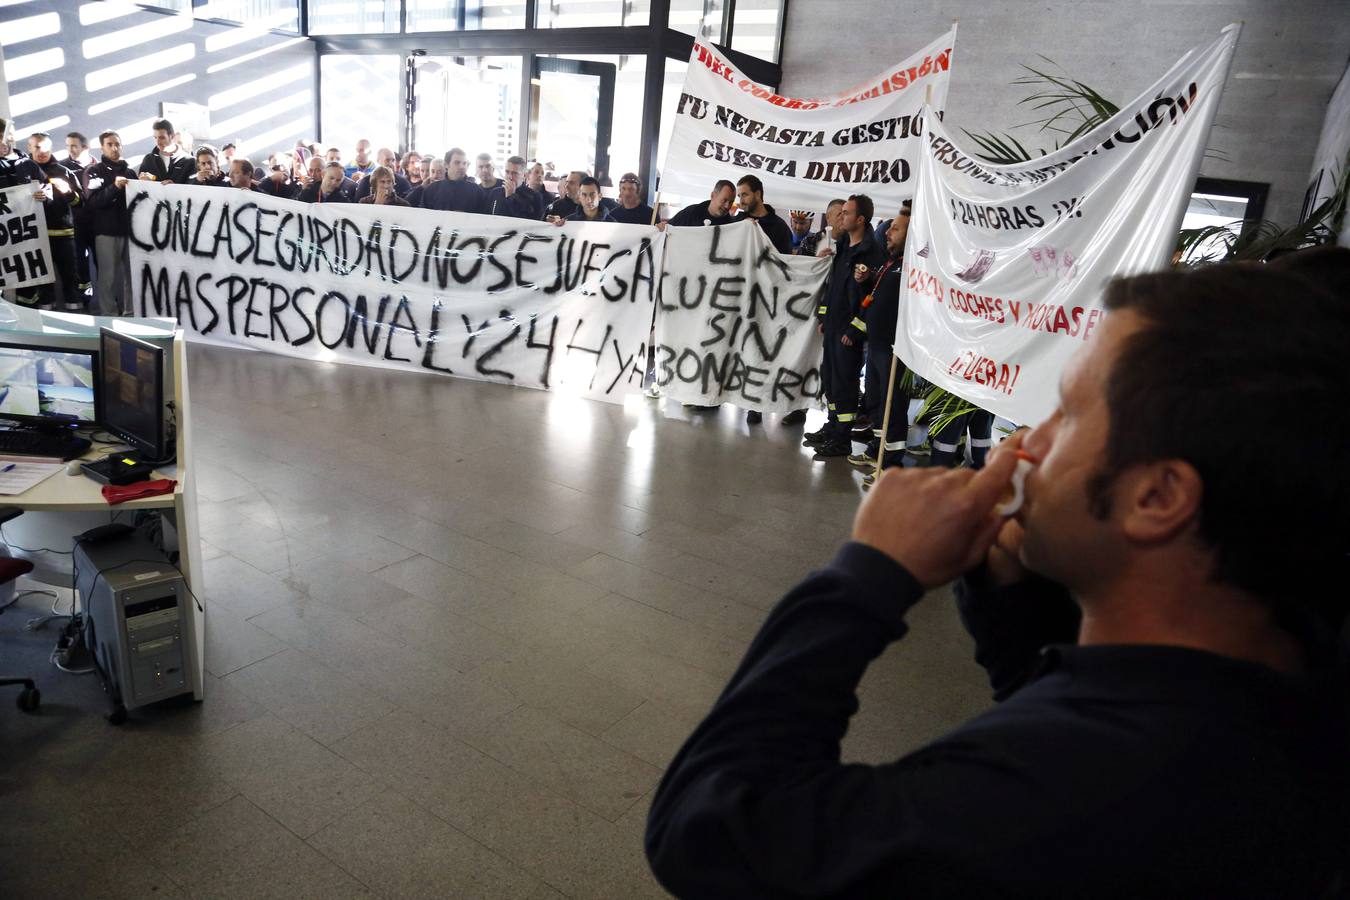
[0,347,987,900]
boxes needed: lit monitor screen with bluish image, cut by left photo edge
[0,344,99,428]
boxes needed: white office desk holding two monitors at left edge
[0,310,205,700]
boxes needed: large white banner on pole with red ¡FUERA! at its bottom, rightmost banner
[895,26,1239,425]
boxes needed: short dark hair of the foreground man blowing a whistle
[1088,260,1350,627]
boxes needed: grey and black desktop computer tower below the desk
[74,529,192,715]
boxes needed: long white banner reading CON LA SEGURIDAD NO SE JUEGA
[127,182,664,402]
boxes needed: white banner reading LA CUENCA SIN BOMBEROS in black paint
[656,221,830,413]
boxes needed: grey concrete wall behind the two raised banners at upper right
[782,0,1350,224]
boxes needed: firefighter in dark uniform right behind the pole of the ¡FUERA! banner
[848,200,910,483]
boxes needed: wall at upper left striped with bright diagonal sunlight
[0,0,319,165]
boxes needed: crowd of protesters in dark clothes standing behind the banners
[0,119,966,477]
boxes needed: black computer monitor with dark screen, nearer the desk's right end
[99,328,167,461]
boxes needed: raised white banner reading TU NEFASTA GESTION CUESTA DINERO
[660,26,956,210]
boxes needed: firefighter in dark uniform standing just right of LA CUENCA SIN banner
[803,194,886,459]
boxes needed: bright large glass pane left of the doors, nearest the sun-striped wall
[319,54,404,153]
